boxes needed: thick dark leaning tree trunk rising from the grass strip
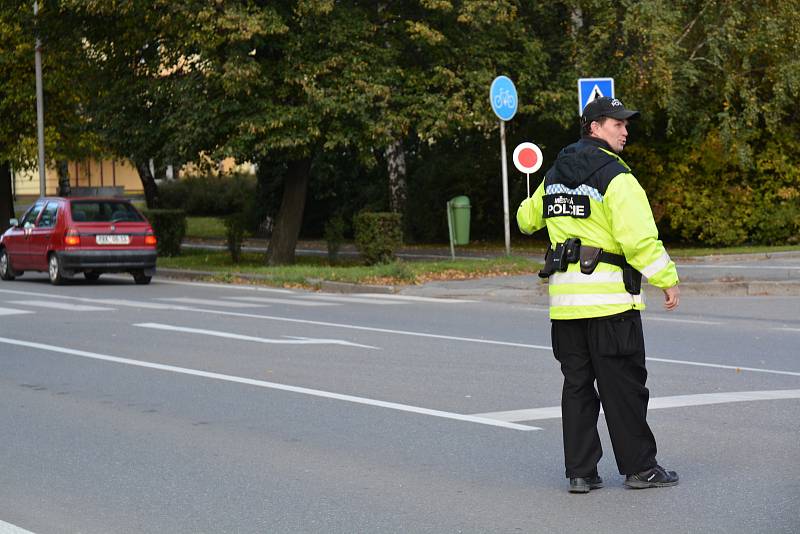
[267,157,311,265]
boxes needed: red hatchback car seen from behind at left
[0,198,156,284]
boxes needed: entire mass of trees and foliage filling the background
[0,0,800,248]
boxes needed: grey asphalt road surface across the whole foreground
[0,275,800,534]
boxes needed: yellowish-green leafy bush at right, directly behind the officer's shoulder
[628,131,800,246]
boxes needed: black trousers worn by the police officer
[552,310,656,478]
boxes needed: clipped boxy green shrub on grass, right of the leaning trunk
[353,211,403,265]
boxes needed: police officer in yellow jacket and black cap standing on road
[517,97,679,493]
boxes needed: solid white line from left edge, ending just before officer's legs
[0,337,541,436]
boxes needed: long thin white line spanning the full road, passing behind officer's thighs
[0,289,800,376]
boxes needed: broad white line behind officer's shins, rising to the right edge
[475,389,800,423]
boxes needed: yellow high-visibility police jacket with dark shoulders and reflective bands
[517,137,678,319]
